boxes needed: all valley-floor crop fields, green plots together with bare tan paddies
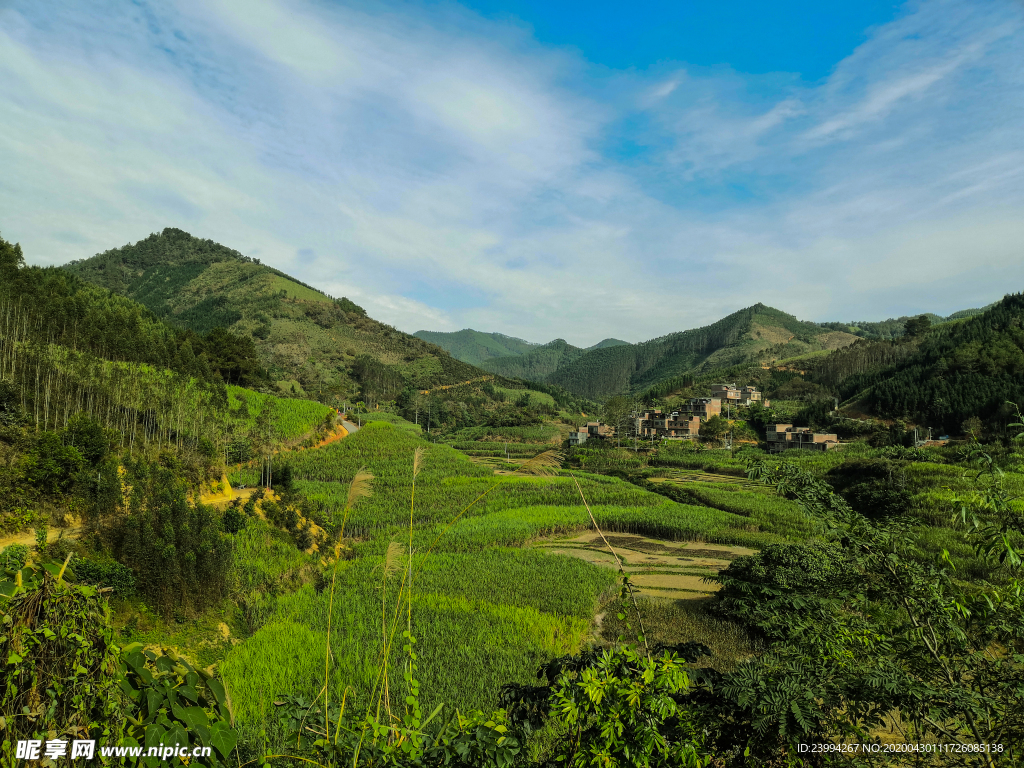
[216,418,1024,753]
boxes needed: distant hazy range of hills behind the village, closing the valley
[483,304,857,399]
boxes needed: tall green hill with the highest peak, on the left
[65,228,485,401]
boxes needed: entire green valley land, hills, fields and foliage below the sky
[0,229,1024,768]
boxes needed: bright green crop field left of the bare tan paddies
[223,422,780,727]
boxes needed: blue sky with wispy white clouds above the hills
[0,0,1024,345]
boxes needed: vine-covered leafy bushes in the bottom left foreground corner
[0,562,237,768]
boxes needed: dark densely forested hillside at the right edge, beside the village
[807,294,1024,434]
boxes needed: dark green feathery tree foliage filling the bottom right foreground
[706,462,1024,766]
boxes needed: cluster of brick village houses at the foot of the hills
[568,384,839,453]
